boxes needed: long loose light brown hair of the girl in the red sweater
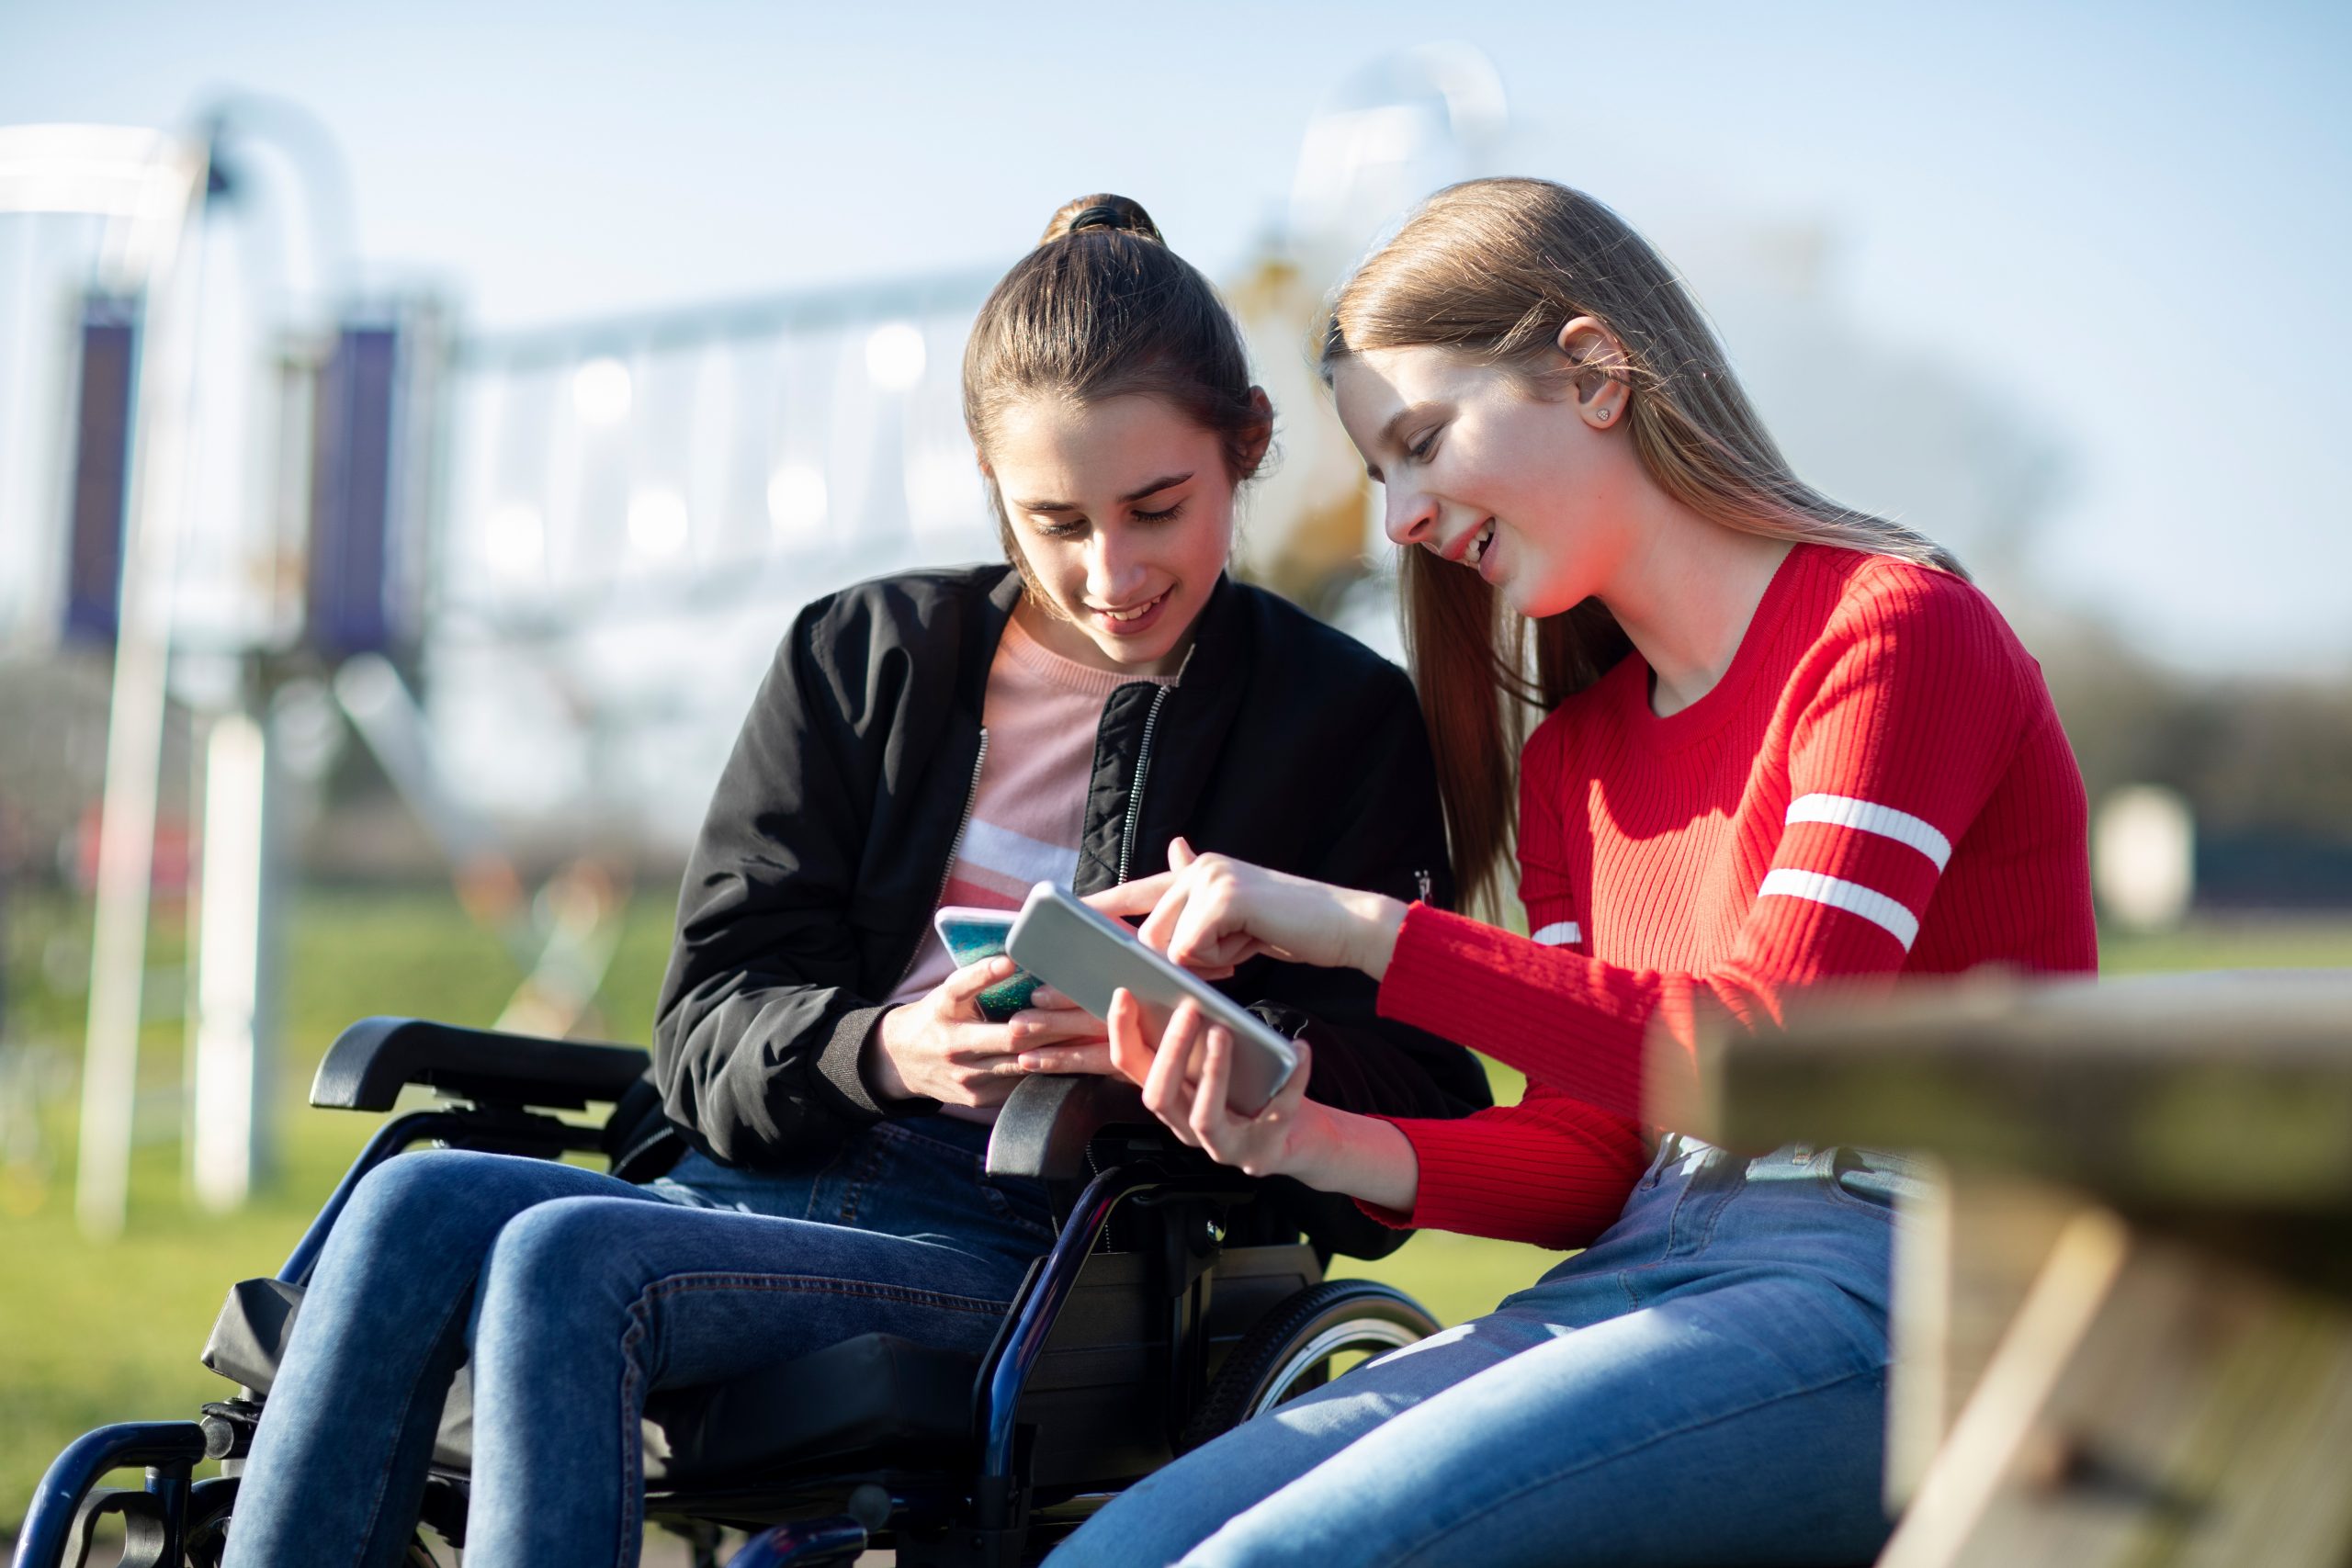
[1322,179,1959,909]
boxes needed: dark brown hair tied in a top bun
[965,195,1268,576]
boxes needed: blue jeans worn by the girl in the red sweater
[1051,1138,1907,1568]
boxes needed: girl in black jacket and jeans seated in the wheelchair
[226,197,1484,1568]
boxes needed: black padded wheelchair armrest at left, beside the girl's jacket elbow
[311,1018,647,1110]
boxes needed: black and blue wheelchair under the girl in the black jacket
[14,1018,1437,1568]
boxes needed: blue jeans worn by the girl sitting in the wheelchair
[226,1117,1054,1568]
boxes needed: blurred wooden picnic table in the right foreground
[1691,971,2352,1568]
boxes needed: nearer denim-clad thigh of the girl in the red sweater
[1183,1269,1886,1568]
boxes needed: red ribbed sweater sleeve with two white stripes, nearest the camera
[1381,585,2030,1117]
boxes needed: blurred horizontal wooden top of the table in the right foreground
[1681,971,2352,1213]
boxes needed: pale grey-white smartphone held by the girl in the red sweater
[1004,882,1298,1117]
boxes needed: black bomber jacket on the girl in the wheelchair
[654,564,1488,1258]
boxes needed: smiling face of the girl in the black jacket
[988,395,1232,674]
